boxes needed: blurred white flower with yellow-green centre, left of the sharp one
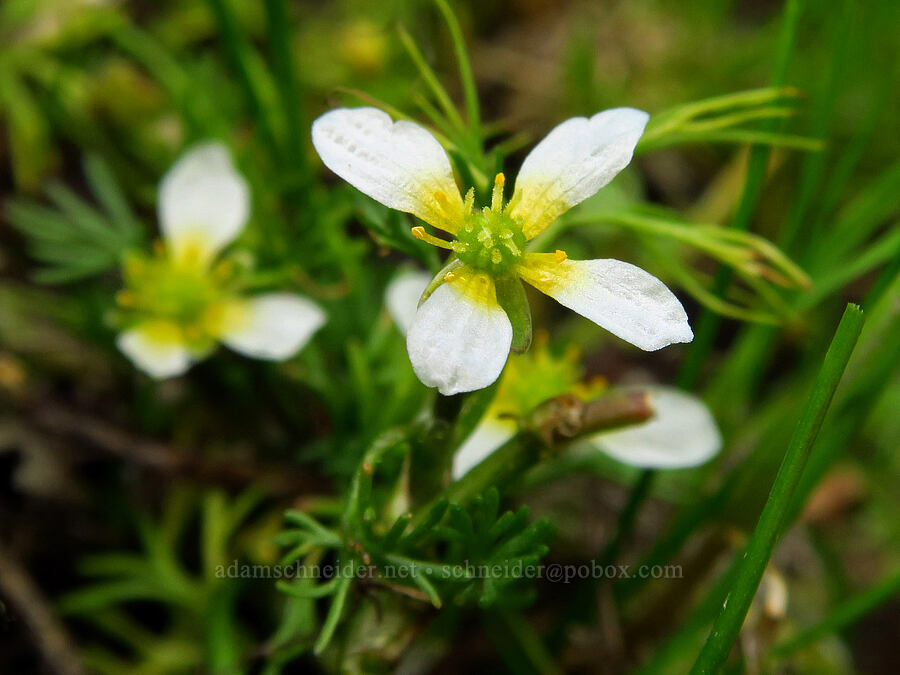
[117,143,325,379]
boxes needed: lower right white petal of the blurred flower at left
[221,293,325,361]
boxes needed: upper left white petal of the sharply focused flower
[312,108,463,233]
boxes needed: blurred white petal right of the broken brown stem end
[591,387,722,469]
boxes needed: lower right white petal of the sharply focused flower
[519,253,694,351]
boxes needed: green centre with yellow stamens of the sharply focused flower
[413,173,526,277]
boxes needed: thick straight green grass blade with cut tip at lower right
[691,305,864,674]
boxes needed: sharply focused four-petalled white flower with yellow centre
[312,108,693,395]
